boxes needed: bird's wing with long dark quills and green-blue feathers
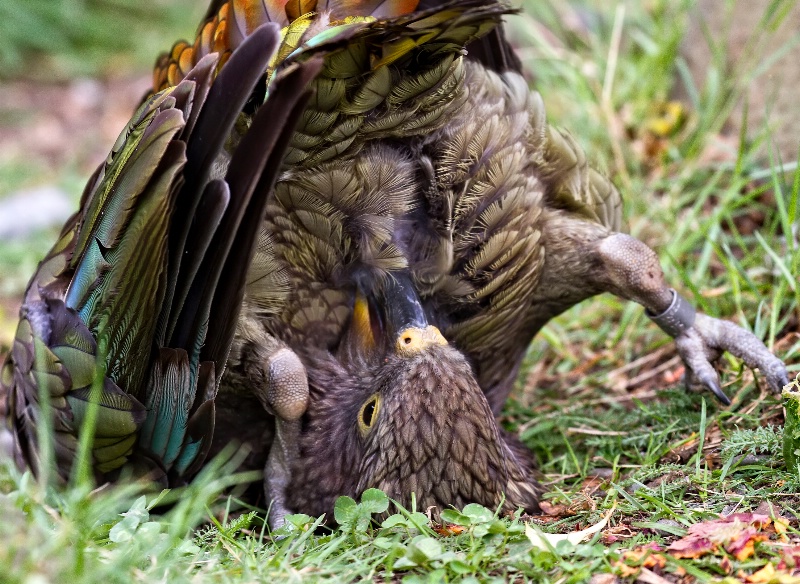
[0,24,321,480]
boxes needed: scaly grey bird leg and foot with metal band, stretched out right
[597,233,789,405]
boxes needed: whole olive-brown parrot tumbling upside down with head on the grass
[0,0,788,523]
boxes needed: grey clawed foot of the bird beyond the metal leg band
[675,314,789,406]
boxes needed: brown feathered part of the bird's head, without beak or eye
[287,346,541,514]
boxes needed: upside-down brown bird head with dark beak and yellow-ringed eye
[287,275,540,514]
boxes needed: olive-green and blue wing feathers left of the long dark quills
[0,81,193,479]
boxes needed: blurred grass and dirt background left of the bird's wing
[0,0,206,342]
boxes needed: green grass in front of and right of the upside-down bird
[0,0,800,582]
